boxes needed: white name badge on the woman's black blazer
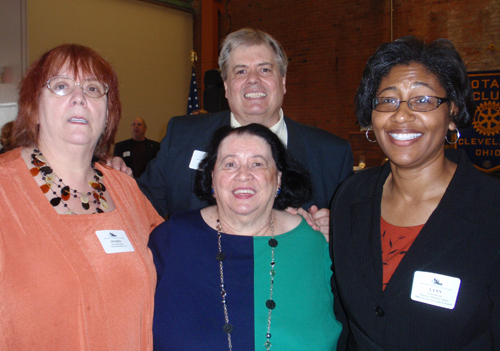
[411,271,460,310]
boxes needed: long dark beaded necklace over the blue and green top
[215,218,278,351]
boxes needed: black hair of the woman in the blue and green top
[194,123,312,210]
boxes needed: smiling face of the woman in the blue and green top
[212,134,281,218]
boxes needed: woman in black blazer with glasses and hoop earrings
[330,37,500,351]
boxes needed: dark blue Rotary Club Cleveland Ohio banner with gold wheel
[456,71,500,173]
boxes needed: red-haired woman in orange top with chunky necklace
[0,44,162,350]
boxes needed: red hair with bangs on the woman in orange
[12,44,121,160]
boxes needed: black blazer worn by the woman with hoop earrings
[330,150,500,351]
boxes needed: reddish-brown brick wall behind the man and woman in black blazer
[194,0,500,166]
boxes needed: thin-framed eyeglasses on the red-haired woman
[47,76,109,98]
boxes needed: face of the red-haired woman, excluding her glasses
[38,64,107,150]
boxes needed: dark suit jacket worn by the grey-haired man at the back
[138,111,353,216]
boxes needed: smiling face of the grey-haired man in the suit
[224,44,286,127]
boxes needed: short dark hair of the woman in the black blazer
[355,36,476,128]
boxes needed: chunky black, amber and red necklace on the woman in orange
[30,148,108,215]
